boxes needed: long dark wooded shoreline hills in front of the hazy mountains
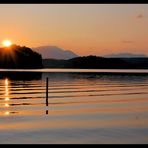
[43,56,148,69]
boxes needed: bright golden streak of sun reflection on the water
[4,78,10,115]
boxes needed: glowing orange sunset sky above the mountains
[0,4,148,56]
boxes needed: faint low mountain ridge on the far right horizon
[104,53,146,58]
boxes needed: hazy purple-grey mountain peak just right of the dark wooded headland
[33,46,78,60]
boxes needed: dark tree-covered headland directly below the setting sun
[0,44,43,69]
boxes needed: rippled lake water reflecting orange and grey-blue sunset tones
[0,69,148,143]
